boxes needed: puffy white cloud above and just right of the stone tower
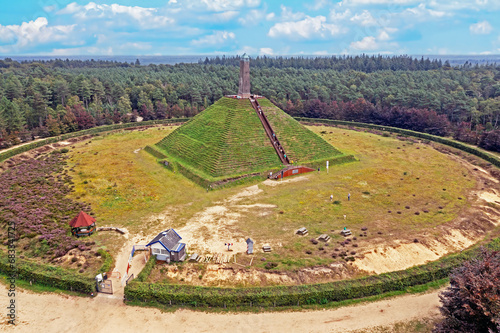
[268,16,345,40]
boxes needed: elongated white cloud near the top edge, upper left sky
[57,2,174,29]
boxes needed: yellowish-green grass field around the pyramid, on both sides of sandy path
[68,126,476,269]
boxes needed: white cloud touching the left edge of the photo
[0,17,76,52]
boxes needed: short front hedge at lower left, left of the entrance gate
[0,252,95,294]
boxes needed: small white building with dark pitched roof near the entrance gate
[146,229,186,263]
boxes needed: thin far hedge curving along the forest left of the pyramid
[0,118,188,162]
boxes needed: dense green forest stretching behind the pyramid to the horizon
[0,55,500,151]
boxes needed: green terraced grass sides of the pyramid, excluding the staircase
[153,97,352,181]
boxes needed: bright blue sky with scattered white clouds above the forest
[0,0,500,56]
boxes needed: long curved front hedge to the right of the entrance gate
[125,238,500,307]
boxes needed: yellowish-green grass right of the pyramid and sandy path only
[228,126,476,270]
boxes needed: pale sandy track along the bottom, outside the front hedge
[0,285,439,333]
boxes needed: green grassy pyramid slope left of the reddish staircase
[156,97,281,178]
